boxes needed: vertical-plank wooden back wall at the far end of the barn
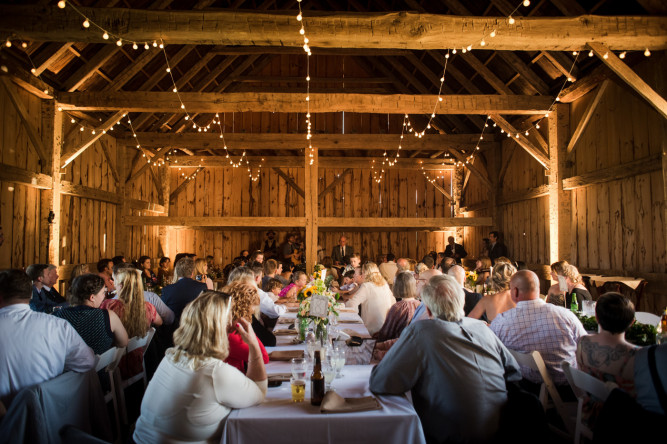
[169,166,453,264]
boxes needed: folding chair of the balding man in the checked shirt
[510,350,574,437]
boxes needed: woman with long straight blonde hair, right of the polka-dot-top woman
[100,267,162,378]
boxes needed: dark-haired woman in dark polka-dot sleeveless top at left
[54,274,127,355]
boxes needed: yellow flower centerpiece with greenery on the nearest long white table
[297,265,338,341]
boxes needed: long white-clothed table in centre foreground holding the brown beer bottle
[222,312,425,444]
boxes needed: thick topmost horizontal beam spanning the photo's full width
[0,5,667,51]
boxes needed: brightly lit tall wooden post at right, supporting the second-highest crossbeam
[549,104,572,263]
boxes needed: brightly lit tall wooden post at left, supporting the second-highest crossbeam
[42,100,62,265]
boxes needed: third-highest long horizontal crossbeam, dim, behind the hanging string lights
[117,132,498,151]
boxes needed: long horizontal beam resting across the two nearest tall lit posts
[58,91,552,114]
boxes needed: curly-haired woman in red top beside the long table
[222,280,268,373]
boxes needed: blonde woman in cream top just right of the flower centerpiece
[345,262,396,335]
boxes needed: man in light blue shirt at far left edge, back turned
[0,270,95,413]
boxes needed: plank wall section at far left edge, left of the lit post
[0,84,47,269]
